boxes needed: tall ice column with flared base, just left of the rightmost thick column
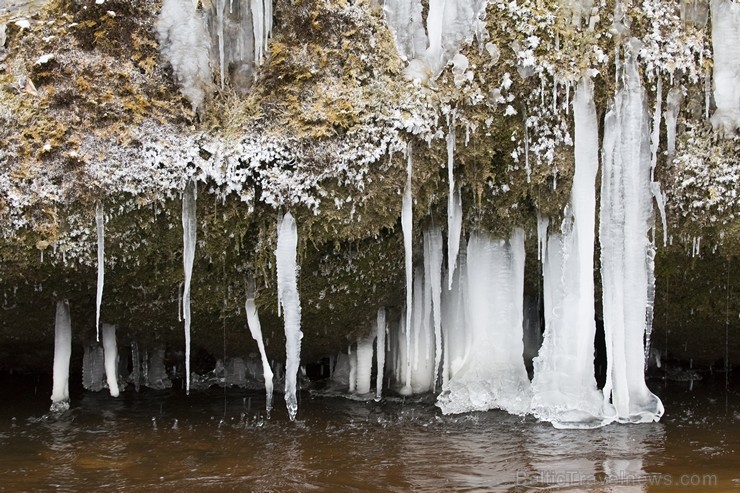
[532,77,613,428]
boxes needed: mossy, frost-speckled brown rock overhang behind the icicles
[0,0,740,371]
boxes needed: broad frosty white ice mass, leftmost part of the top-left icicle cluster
[157,0,212,111]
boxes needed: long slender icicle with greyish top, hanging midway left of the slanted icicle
[182,182,198,393]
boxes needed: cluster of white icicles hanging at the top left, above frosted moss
[157,0,273,110]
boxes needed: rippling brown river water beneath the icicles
[0,376,740,492]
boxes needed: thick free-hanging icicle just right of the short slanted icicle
[275,212,303,421]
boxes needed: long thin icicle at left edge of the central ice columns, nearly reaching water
[401,144,414,395]
